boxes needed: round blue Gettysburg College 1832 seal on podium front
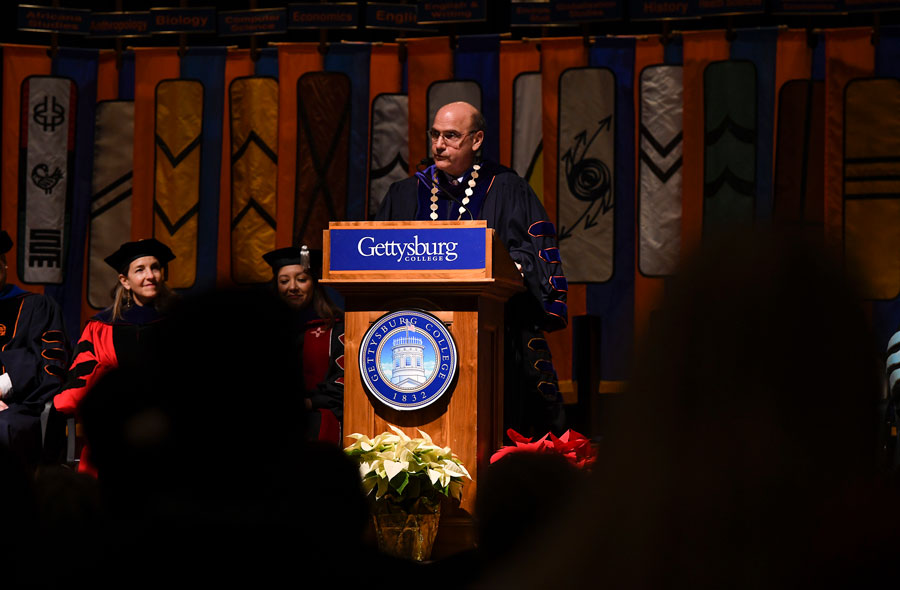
[359,309,457,410]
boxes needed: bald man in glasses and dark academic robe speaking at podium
[375,102,568,435]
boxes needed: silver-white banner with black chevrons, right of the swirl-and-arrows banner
[638,65,684,276]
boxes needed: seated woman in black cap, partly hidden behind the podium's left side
[263,246,344,444]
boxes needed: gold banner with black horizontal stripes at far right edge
[843,78,900,299]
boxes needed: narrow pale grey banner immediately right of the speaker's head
[512,72,544,197]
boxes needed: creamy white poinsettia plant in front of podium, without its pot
[344,426,472,512]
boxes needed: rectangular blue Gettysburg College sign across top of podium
[329,227,487,272]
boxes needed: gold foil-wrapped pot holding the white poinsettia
[372,505,441,561]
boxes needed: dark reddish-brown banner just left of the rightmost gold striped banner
[773,80,825,230]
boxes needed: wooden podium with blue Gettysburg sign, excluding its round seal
[321,221,524,557]
